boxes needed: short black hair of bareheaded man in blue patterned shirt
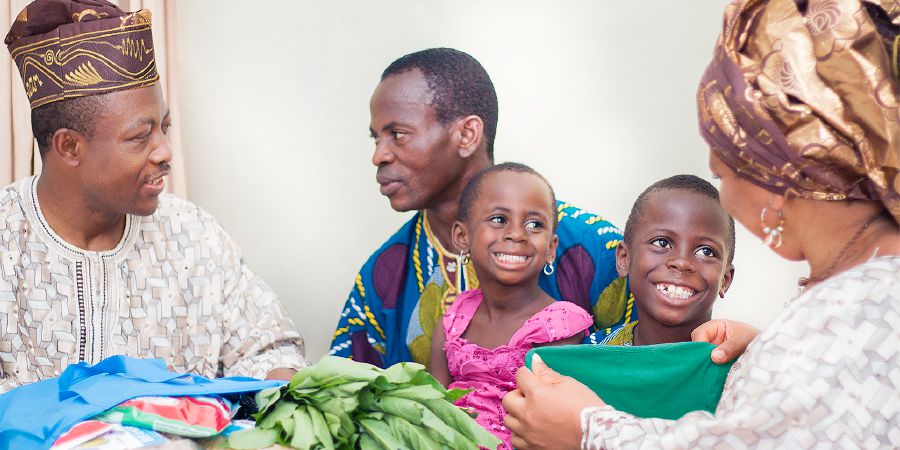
[381,48,497,162]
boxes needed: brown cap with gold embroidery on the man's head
[4,0,159,108]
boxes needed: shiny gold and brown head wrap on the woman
[697,0,900,223]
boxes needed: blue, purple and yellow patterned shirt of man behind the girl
[329,202,637,367]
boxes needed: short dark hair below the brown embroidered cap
[31,95,107,156]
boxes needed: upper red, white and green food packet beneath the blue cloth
[95,397,231,437]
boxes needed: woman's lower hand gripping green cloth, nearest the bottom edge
[503,355,605,450]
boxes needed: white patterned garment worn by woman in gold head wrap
[581,257,900,449]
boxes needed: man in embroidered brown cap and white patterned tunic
[0,0,306,393]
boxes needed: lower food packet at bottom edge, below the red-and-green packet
[50,420,169,450]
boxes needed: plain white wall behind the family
[178,0,804,360]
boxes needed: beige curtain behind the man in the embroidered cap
[0,0,187,197]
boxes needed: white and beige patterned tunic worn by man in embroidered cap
[0,177,306,393]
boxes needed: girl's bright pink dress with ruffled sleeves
[443,289,593,450]
